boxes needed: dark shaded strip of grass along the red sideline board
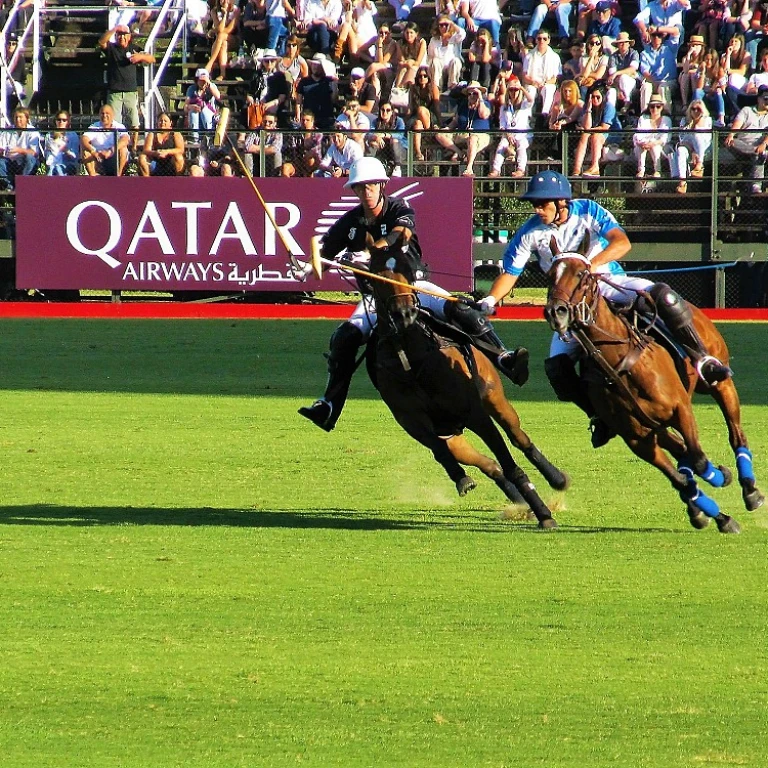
[0,320,768,404]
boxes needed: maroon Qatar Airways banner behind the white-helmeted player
[16,176,472,291]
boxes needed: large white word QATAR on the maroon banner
[65,200,305,276]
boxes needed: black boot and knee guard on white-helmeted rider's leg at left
[299,322,365,432]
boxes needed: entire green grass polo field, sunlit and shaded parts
[0,321,768,768]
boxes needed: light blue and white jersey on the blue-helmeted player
[503,200,624,276]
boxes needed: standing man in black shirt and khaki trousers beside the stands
[99,24,155,138]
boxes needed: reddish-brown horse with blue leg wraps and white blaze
[545,251,762,533]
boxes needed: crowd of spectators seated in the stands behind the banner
[0,0,768,194]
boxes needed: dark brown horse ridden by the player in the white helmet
[369,260,569,528]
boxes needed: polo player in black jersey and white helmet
[299,157,528,432]
